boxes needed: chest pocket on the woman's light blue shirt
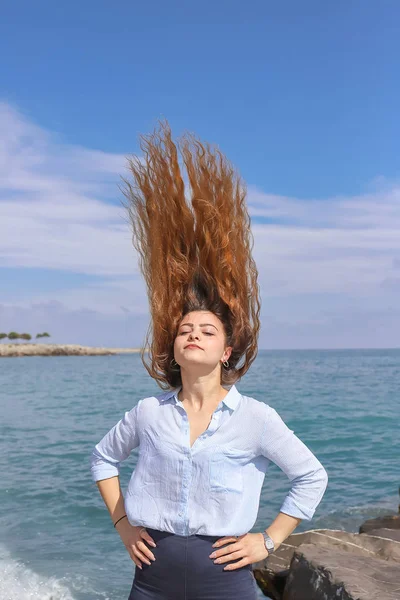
[209,449,243,494]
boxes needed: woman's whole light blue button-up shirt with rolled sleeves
[91,385,328,536]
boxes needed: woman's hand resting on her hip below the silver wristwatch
[210,533,268,571]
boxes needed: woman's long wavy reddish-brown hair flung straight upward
[122,122,260,389]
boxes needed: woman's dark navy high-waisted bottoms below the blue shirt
[128,527,257,600]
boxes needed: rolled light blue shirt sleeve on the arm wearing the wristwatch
[261,406,328,521]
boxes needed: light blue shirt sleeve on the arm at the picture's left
[90,400,142,482]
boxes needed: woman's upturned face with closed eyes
[174,310,232,370]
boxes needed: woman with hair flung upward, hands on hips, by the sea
[91,123,327,600]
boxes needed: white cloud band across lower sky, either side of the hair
[0,103,400,347]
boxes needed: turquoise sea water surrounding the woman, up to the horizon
[0,350,400,600]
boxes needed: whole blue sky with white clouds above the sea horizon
[0,0,400,348]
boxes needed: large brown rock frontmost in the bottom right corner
[282,542,400,600]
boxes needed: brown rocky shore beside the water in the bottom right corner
[253,504,400,600]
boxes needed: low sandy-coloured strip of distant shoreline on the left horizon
[0,343,142,358]
